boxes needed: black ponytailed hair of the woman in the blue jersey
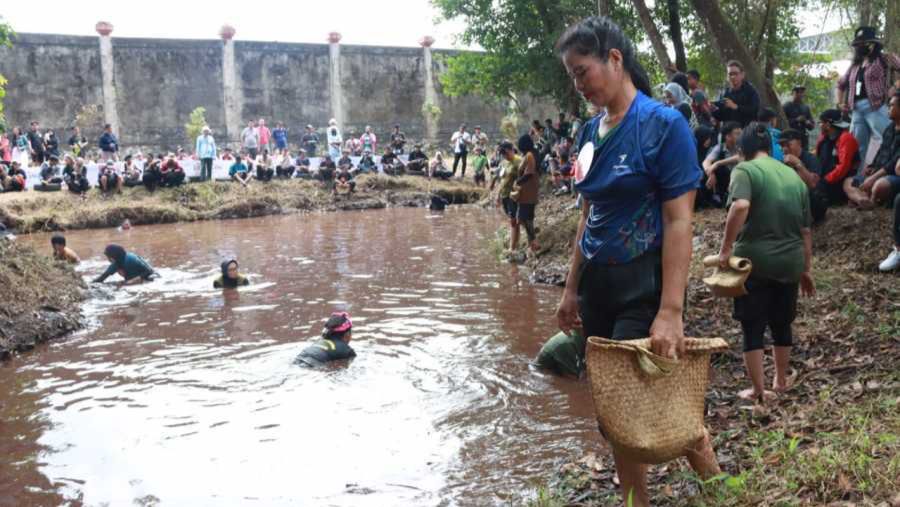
[556,16,653,97]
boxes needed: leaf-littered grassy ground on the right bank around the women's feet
[512,193,900,507]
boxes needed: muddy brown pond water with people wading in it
[0,207,599,506]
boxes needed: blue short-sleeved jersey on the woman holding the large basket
[574,92,702,264]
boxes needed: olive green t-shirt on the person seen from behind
[728,157,812,283]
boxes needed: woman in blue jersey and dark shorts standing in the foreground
[557,17,719,506]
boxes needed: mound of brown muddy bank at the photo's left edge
[0,239,84,360]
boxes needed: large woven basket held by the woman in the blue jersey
[586,336,728,464]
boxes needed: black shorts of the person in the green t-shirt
[733,275,800,352]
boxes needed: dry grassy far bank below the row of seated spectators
[0,175,482,233]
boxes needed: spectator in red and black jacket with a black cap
[816,109,860,206]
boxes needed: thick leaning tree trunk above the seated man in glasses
[691,0,787,125]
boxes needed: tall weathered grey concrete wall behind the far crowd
[0,34,551,150]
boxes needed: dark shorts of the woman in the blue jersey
[578,250,662,340]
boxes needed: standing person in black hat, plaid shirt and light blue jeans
[838,26,900,162]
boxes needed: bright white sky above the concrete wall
[2,0,472,48]
